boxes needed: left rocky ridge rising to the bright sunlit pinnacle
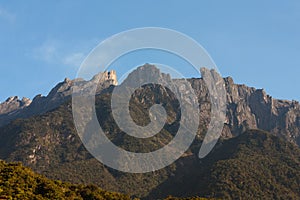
[0,70,118,127]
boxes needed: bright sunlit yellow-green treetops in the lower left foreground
[0,161,130,200]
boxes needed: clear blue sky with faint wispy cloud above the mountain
[0,0,300,101]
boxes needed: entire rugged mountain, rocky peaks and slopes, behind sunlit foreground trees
[0,65,300,199]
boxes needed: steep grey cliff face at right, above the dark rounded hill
[190,77,300,145]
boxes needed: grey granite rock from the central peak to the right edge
[113,64,300,146]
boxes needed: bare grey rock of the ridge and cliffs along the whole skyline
[0,64,300,145]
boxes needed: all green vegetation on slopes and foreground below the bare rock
[0,85,300,200]
